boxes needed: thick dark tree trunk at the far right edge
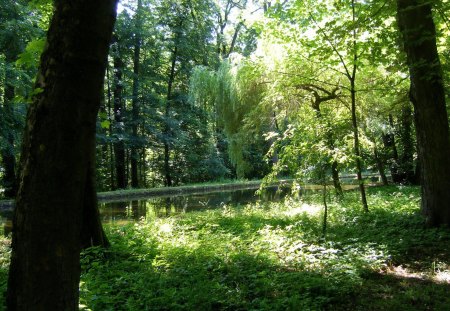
[397,0,450,226]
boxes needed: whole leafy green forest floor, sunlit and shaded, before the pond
[0,186,450,311]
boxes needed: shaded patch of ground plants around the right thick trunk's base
[328,202,450,272]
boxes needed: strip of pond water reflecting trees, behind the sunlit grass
[100,188,287,223]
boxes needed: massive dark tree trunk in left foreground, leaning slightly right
[7,0,116,310]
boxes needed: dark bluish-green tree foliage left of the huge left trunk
[0,1,39,198]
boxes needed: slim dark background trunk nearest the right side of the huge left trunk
[113,42,127,189]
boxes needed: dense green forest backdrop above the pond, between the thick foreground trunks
[0,0,450,197]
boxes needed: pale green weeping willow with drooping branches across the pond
[190,57,271,178]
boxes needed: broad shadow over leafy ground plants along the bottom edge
[81,241,450,310]
